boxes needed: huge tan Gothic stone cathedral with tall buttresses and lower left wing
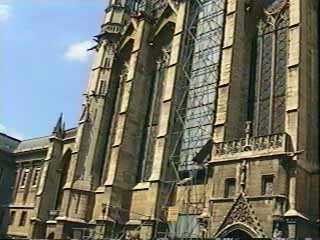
[3,0,320,239]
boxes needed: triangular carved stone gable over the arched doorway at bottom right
[218,192,266,237]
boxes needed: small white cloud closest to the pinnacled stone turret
[64,41,93,62]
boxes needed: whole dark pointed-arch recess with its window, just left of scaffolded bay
[136,22,175,182]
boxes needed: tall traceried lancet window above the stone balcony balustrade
[253,0,289,136]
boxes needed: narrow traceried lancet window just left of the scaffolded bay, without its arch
[137,45,171,182]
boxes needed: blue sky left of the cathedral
[0,0,107,139]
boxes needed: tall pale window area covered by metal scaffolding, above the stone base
[170,0,225,174]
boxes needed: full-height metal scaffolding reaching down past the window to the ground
[162,0,226,239]
